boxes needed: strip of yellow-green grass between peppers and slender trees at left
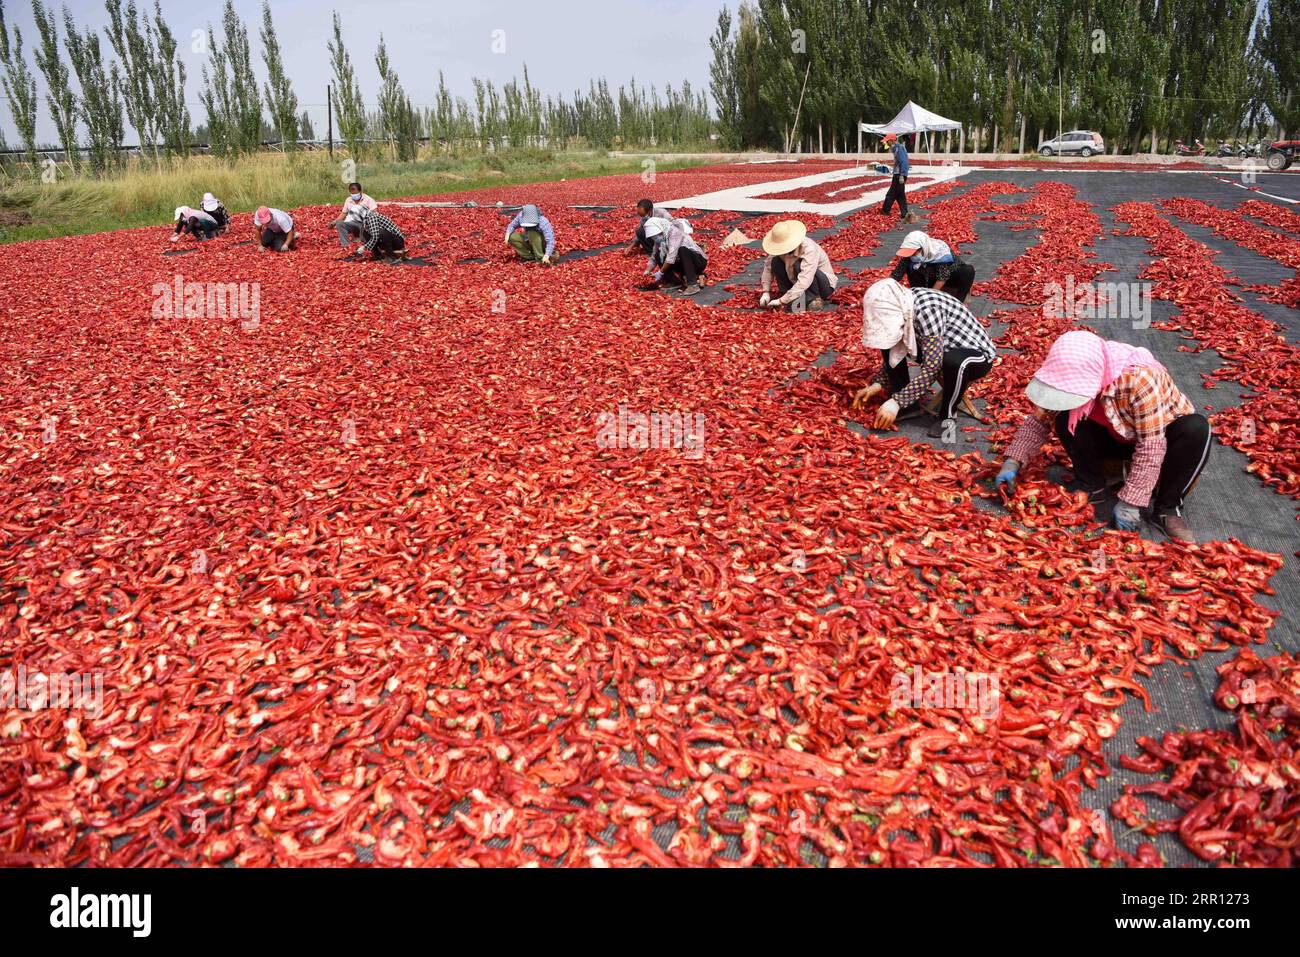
[0,150,698,243]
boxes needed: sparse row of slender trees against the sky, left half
[0,0,712,173]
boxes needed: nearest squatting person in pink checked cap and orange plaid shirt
[997,329,1210,542]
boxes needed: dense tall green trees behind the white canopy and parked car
[711,0,1300,152]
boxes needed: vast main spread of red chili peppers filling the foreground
[0,160,1295,866]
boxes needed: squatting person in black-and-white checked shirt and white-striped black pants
[853,280,997,438]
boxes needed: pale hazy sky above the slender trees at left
[0,0,736,147]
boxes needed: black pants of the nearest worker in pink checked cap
[1056,412,1213,515]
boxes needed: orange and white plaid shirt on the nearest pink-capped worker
[1006,365,1196,508]
